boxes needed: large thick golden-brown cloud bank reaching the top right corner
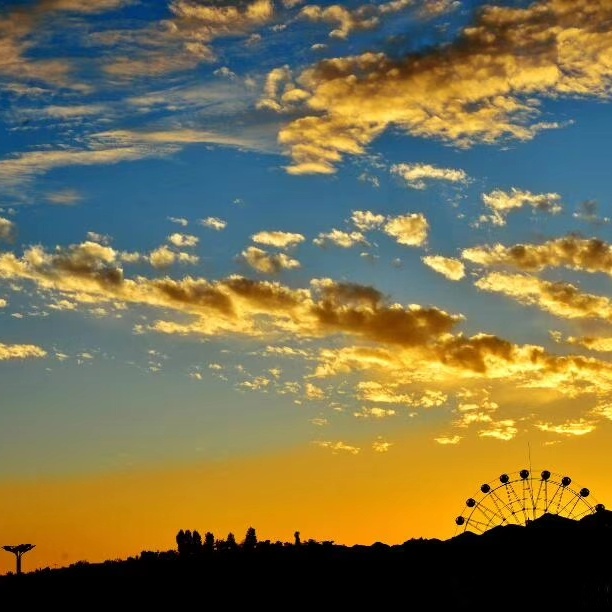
[277,0,612,174]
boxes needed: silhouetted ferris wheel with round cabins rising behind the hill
[455,470,605,533]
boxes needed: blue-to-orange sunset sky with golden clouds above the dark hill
[0,0,612,573]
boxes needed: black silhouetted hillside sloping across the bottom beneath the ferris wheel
[0,511,612,612]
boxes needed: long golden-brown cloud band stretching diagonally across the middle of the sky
[5,241,612,438]
